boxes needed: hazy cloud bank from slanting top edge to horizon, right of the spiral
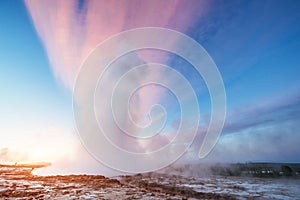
[194,91,300,162]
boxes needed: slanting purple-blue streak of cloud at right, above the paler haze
[224,89,300,134]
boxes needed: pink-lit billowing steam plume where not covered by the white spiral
[25,0,208,175]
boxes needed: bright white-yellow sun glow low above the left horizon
[0,129,79,164]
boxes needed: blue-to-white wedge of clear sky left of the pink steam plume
[0,1,73,168]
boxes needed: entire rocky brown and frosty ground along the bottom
[0,170,300,199]
